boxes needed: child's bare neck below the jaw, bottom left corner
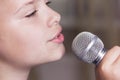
[0,61,30,80]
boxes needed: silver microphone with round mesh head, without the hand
[72,32,106,65]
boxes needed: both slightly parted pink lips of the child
[50,30,64,43]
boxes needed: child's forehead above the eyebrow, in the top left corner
[0,0,35,18]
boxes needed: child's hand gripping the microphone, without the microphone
[96,46,120,80]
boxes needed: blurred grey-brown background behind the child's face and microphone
[29,0,120,80]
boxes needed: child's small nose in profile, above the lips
[48,9,61,27]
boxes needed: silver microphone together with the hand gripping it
[72,32,120,80]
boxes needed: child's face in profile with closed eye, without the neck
[0,0,64,66]
